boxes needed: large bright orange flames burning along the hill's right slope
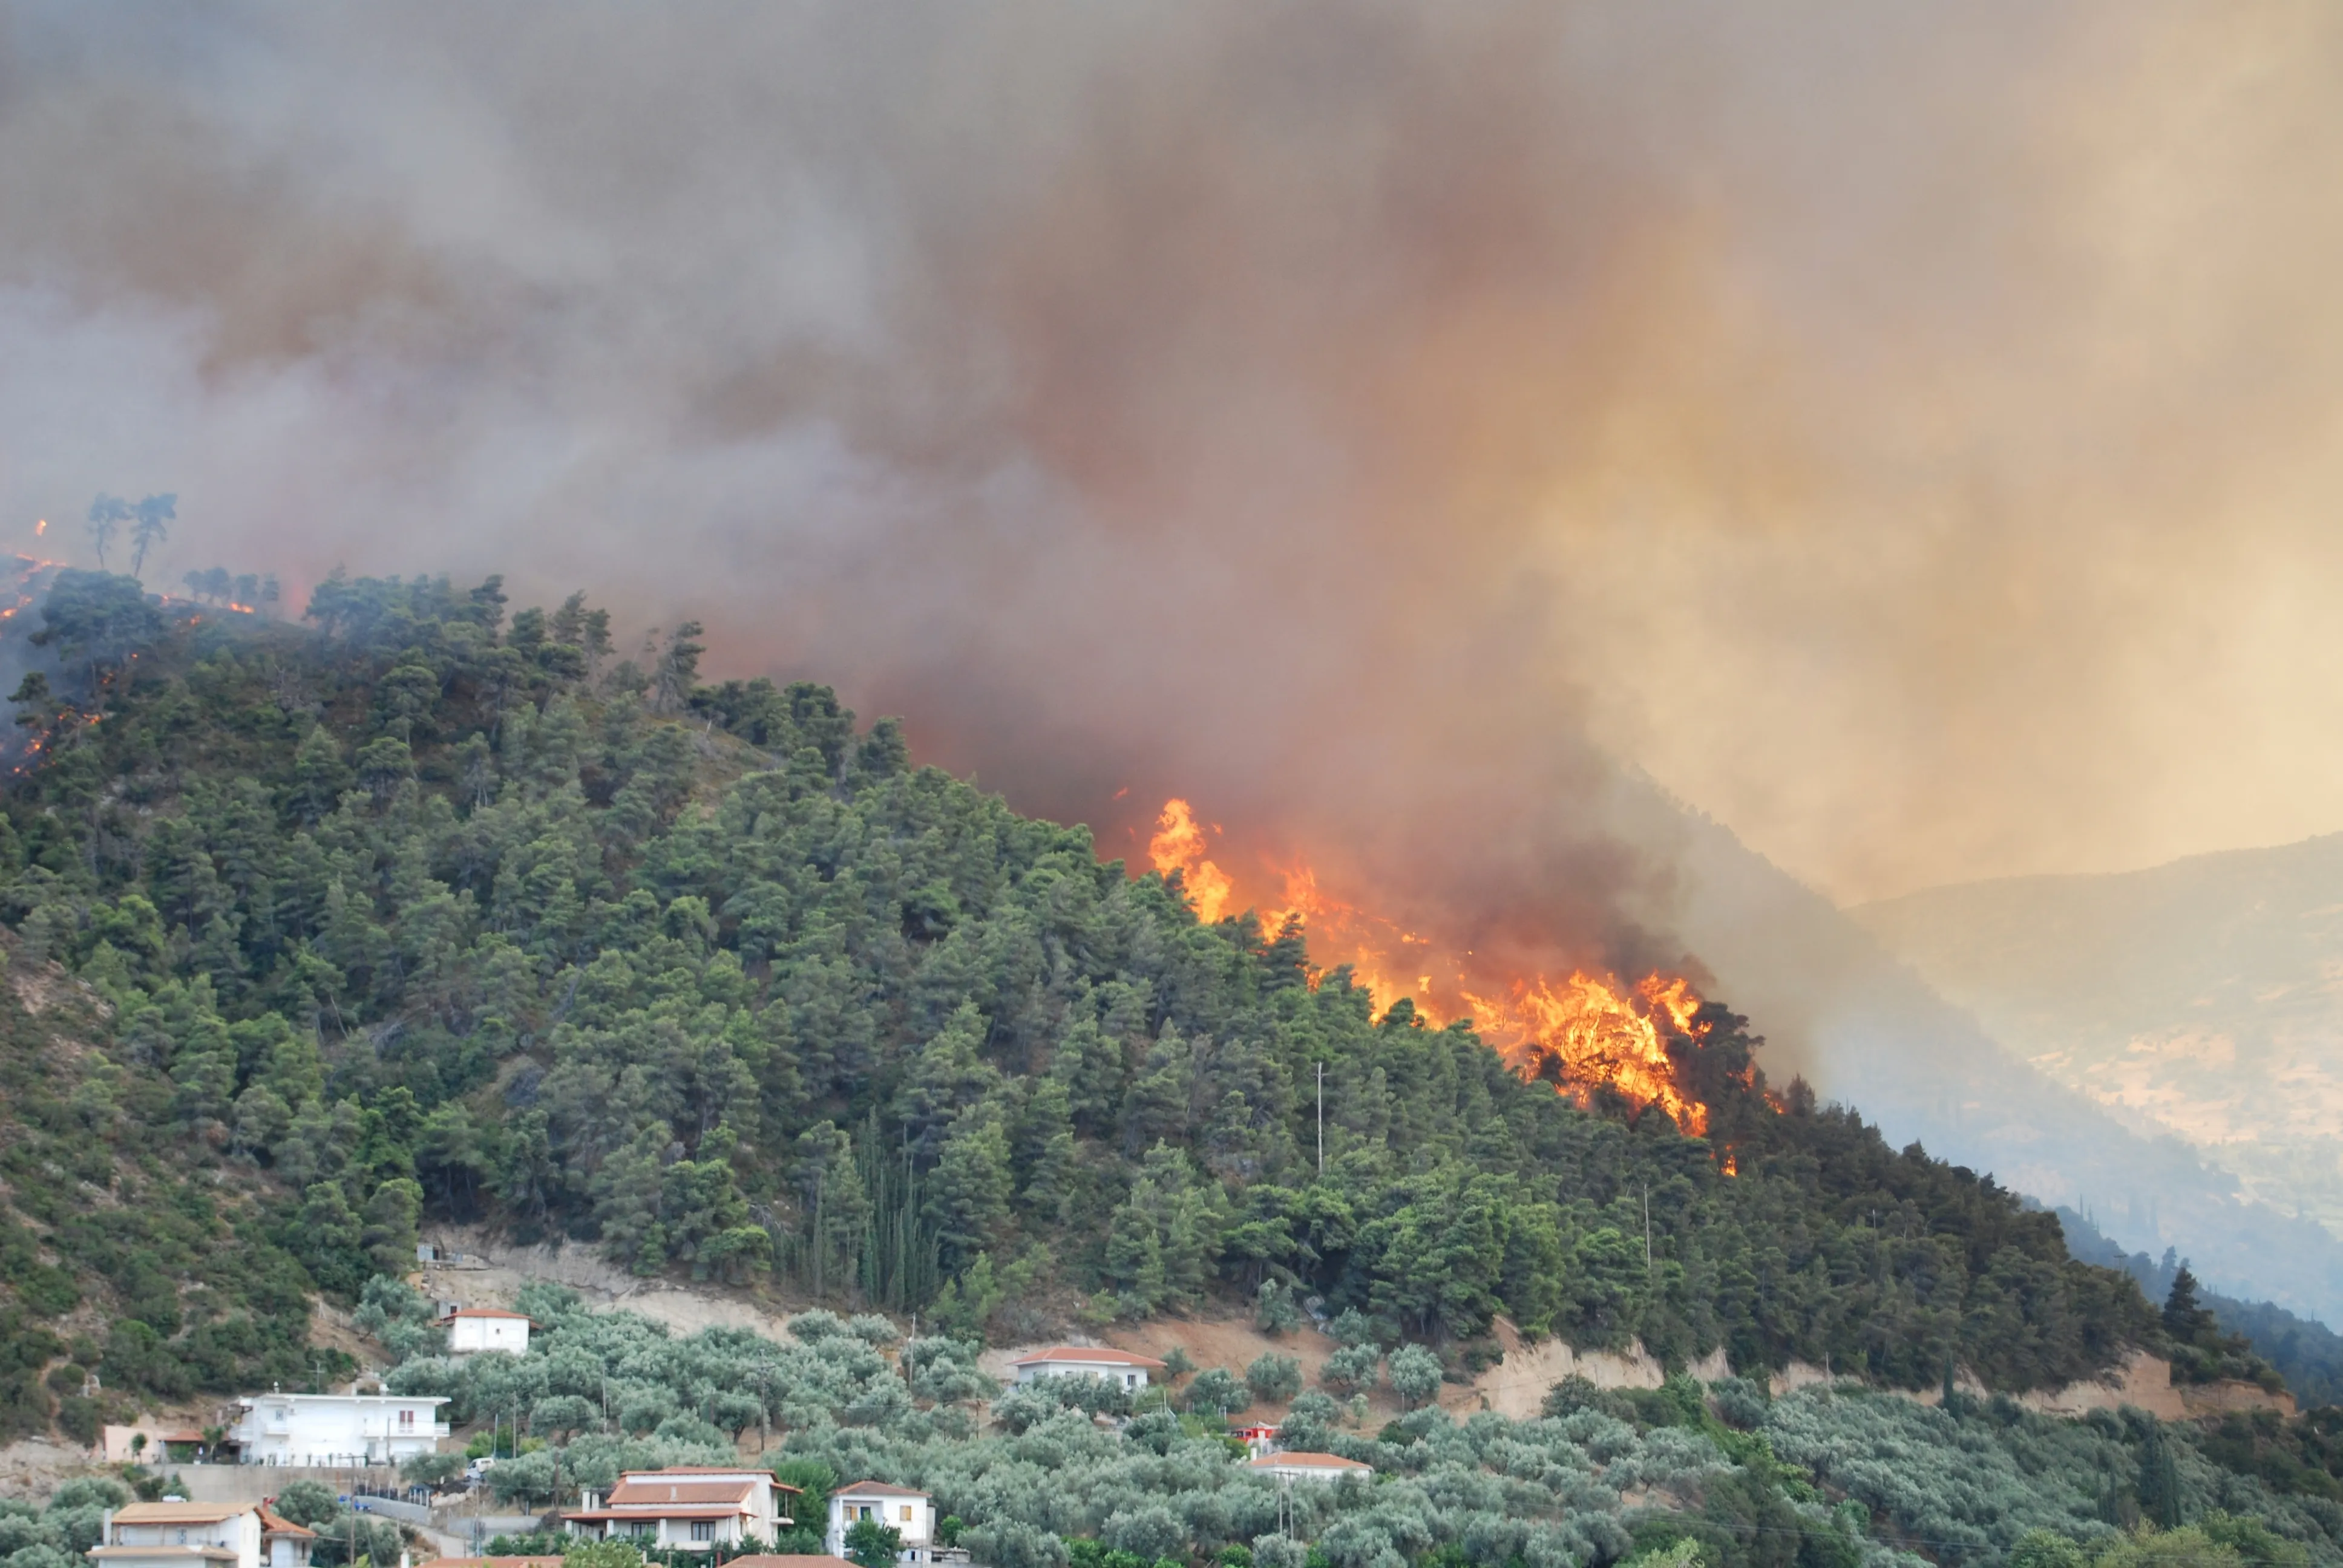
[1148,799,1743,1137]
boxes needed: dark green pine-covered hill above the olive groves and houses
[0,574,2160,1434]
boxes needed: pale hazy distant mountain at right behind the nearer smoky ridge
[1851,834,2343,1252]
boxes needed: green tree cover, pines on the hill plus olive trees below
[13,572,2343,1568]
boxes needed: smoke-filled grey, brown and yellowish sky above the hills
[0,0,2343,904]
